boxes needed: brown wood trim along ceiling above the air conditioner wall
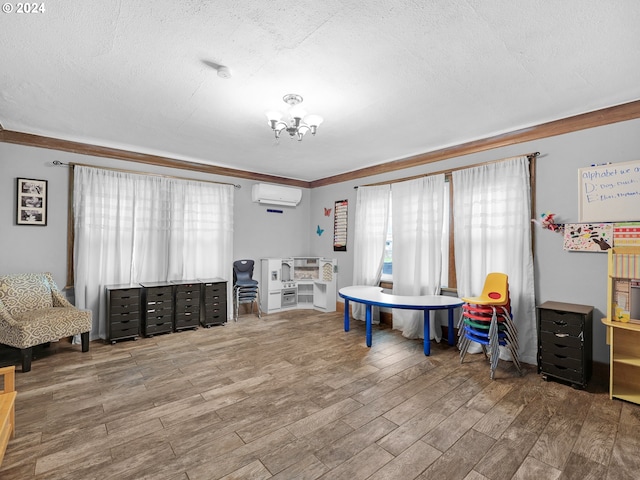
[0,130,309,188]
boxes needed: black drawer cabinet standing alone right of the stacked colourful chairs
[538,302,593,388]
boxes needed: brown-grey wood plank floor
[0,311,640,480]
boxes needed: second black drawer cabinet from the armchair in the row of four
[140,282,173,337]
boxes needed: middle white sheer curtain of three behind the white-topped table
[391,174,448,341]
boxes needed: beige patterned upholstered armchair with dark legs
[0,273,91,372]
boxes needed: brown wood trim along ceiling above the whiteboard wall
[311,100,640,188]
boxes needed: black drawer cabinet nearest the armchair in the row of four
[106,285,142,343]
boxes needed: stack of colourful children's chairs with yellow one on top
[458,273,522,379]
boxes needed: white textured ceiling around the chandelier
[0,0,640,180]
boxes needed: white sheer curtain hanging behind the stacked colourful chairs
[452,156,537,364]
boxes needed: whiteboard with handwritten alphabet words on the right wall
[578,160,640,222]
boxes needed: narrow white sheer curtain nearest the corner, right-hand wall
[350,185,391,321]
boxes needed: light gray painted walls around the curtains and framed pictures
[0,120,640,363]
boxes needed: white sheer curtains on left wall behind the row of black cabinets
[73,166,233,338]
